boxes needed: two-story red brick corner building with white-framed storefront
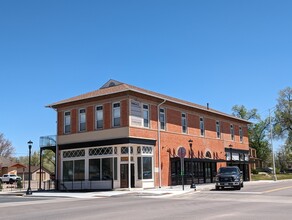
[47,80,250,189]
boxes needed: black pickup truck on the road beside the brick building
[215,166,243,190]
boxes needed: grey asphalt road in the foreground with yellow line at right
[0,181,292,220]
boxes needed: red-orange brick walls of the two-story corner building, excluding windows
[58,95,248,186]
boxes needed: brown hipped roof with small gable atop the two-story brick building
[46,79,250,123]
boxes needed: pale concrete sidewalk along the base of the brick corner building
[0,183,214,199]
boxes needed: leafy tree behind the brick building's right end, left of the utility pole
[232,105,271,166]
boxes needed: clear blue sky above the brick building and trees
[0,0,292,156]
